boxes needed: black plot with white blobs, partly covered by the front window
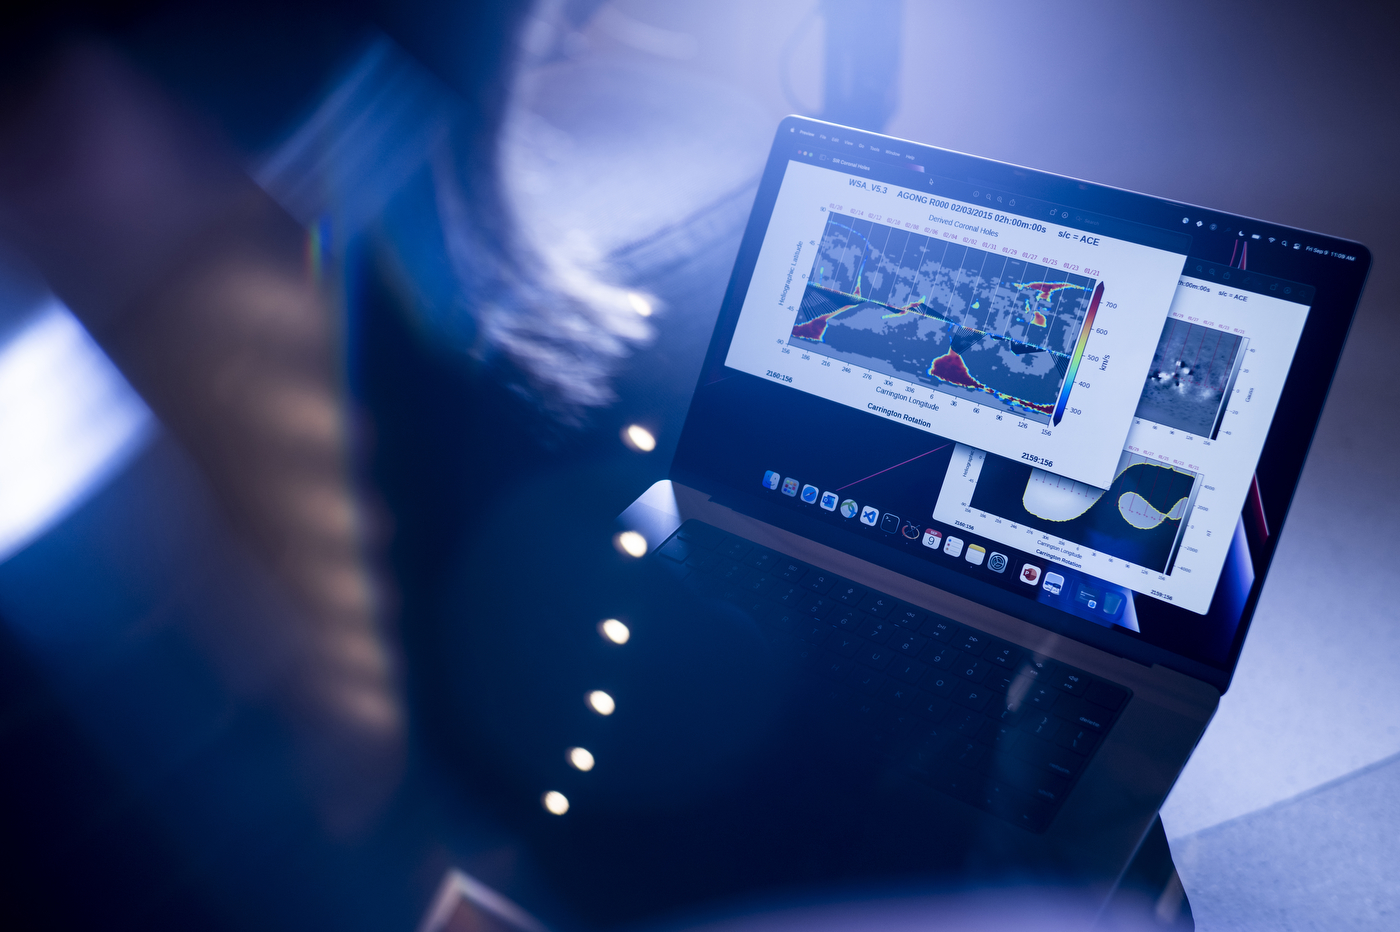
[967,452,1201,574]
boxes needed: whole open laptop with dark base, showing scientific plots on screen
[495,116,1371,924]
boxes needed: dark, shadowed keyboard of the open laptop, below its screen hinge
[657,521,1130,833]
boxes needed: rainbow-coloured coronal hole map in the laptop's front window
[788,214,1096,423]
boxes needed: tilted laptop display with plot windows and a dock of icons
[675,118,1369,684]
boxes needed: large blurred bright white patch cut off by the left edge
[0,299,155,560]
